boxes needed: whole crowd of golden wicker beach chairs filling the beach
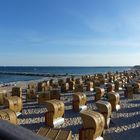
[0,72,140,140]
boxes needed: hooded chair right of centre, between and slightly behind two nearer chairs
[95,87,105,101]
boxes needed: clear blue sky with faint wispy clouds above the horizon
[0,0,140,66]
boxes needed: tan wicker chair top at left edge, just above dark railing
[0,109,17,124]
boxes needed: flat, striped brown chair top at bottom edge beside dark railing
[37,127,72,140]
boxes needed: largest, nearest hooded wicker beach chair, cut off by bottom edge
[79,110,105,140]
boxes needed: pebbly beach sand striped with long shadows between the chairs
[1,77,140,140]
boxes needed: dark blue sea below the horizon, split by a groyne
[0,66,132,84]
